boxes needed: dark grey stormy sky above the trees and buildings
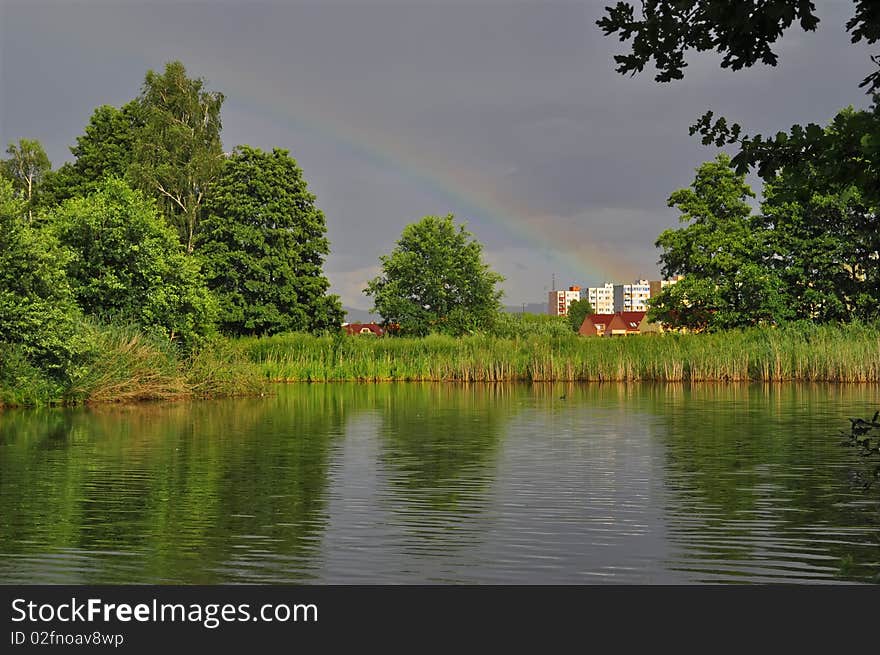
[0,0,871,308]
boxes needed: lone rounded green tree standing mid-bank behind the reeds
[364,214,504,335]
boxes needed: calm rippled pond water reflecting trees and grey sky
[0,384,880,583]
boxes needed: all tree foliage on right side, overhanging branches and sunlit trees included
[598,0,880,334]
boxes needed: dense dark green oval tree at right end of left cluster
[198,145,343,334]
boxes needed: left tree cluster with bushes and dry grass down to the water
[0,62,342,405]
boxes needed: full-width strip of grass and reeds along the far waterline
[0,325,880,405]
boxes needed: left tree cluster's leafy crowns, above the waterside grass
[3,61,342,342]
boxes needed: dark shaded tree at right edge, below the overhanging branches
[762,109,880,321]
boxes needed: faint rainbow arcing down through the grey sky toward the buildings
[41,21,639,286]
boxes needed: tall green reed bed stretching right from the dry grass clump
[232,325,880,382]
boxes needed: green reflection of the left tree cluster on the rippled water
[0,386,346,583]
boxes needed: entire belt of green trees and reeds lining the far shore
[0,34,880,406]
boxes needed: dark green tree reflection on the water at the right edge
[645,384,880,581]
